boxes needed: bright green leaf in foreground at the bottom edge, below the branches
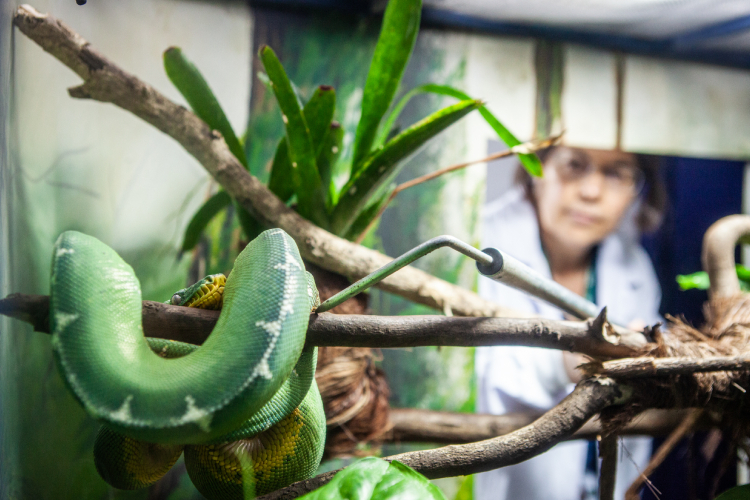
[300,457,445,500]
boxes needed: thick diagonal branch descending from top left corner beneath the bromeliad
[14,5,525,317]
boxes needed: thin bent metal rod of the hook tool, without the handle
[316,235,492,312]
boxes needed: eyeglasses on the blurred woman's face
[545,150,646,194]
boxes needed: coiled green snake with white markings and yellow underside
[50,229,325,499]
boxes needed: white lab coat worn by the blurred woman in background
[474,188,661,500]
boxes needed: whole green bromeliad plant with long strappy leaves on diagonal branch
[164,0,541,251]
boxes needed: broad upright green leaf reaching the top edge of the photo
[351,0,422,172]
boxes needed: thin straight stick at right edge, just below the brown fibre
[583,356,750,378]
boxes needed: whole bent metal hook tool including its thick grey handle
[316,235,599,319]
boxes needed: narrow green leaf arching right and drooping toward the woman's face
[375,84,542,177]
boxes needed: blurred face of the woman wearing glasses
[534,147,643,249]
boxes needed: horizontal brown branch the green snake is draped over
[0,294,634,357]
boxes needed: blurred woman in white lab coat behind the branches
[475,146,665,500]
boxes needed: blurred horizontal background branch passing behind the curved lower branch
[382,408,712,444]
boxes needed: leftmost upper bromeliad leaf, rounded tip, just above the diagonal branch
[164,47,247,168]
